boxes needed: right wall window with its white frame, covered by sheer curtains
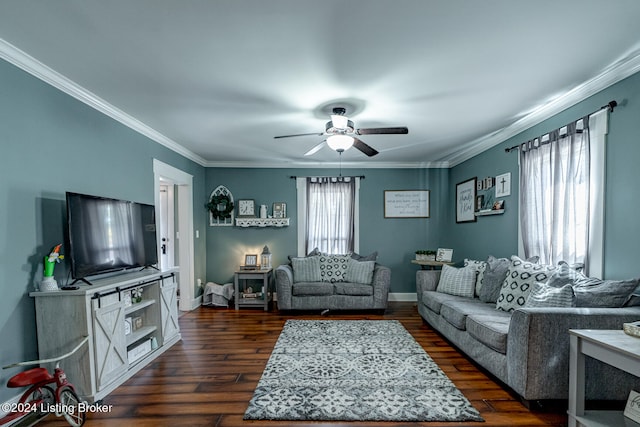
[520,112,608,277]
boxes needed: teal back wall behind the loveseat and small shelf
[203,168,449,292]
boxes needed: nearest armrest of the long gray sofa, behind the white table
[507,307,640,400]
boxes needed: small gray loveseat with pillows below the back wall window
[275,252,391,311]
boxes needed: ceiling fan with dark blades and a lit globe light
[274,107,409,157]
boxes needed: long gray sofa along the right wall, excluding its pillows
[416,258,640,401]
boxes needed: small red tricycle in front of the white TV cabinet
[0,337,88,427]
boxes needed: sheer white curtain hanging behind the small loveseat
[305,177,356,254]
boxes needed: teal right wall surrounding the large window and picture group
[447,73,640,279]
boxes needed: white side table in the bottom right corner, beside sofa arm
[568,329,640,427]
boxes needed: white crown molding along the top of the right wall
[442,46,640,167]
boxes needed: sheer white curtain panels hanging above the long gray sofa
[520,117,590,267]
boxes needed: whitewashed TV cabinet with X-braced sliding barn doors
[30,269,181,402]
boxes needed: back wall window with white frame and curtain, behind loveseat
[297,177,359,255]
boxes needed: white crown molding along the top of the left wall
[0,39,206,166]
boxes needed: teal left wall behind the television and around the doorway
[0,61,206,402]
